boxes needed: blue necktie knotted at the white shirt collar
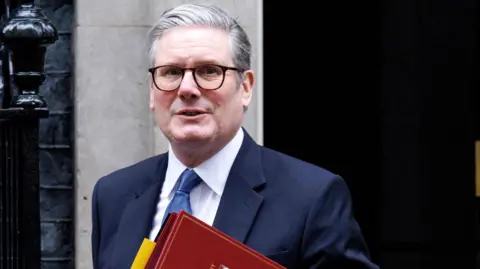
[162,169,202,223]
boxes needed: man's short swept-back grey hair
[148,4,252,70]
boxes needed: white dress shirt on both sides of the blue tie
[149,128,244,241]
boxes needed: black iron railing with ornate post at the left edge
[0,1,58,269]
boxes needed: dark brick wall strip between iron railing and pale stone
[35,0,75,269]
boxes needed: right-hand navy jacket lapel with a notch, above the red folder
[213,130,265,243]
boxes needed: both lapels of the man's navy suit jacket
[112,130,266,269]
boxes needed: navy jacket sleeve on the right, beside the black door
[302,176,379,269]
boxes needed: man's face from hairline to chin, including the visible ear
[150,27,254,147]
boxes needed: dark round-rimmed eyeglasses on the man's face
[148,64,243,91]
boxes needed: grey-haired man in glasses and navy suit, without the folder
[92,4,378,269]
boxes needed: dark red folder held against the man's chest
[145,211,286,269]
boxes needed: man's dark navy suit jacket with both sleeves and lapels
[92,129,378,269]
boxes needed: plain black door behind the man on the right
[264,0,478,269]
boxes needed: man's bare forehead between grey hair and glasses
[154,26,233,66]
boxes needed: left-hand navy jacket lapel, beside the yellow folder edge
[112,155,168,269]
